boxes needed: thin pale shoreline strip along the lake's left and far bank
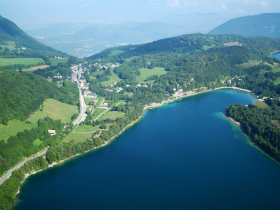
[13,87,254,195]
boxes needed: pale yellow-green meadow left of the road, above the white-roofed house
[28,99,78,123]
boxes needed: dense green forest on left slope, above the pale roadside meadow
[0,71,79,125]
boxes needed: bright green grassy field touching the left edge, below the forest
[0,120,37,141]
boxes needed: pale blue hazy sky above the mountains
[0,0,280,25]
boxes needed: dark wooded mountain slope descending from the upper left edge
[0,16,60,52]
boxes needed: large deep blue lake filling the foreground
[16,90,280,209]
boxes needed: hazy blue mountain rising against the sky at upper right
[209,13,280,38]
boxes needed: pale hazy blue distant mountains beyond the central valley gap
[29,22,195,57]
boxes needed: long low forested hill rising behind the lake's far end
[88,34,280,92]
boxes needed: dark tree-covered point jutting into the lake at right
[226,99,280,161]
